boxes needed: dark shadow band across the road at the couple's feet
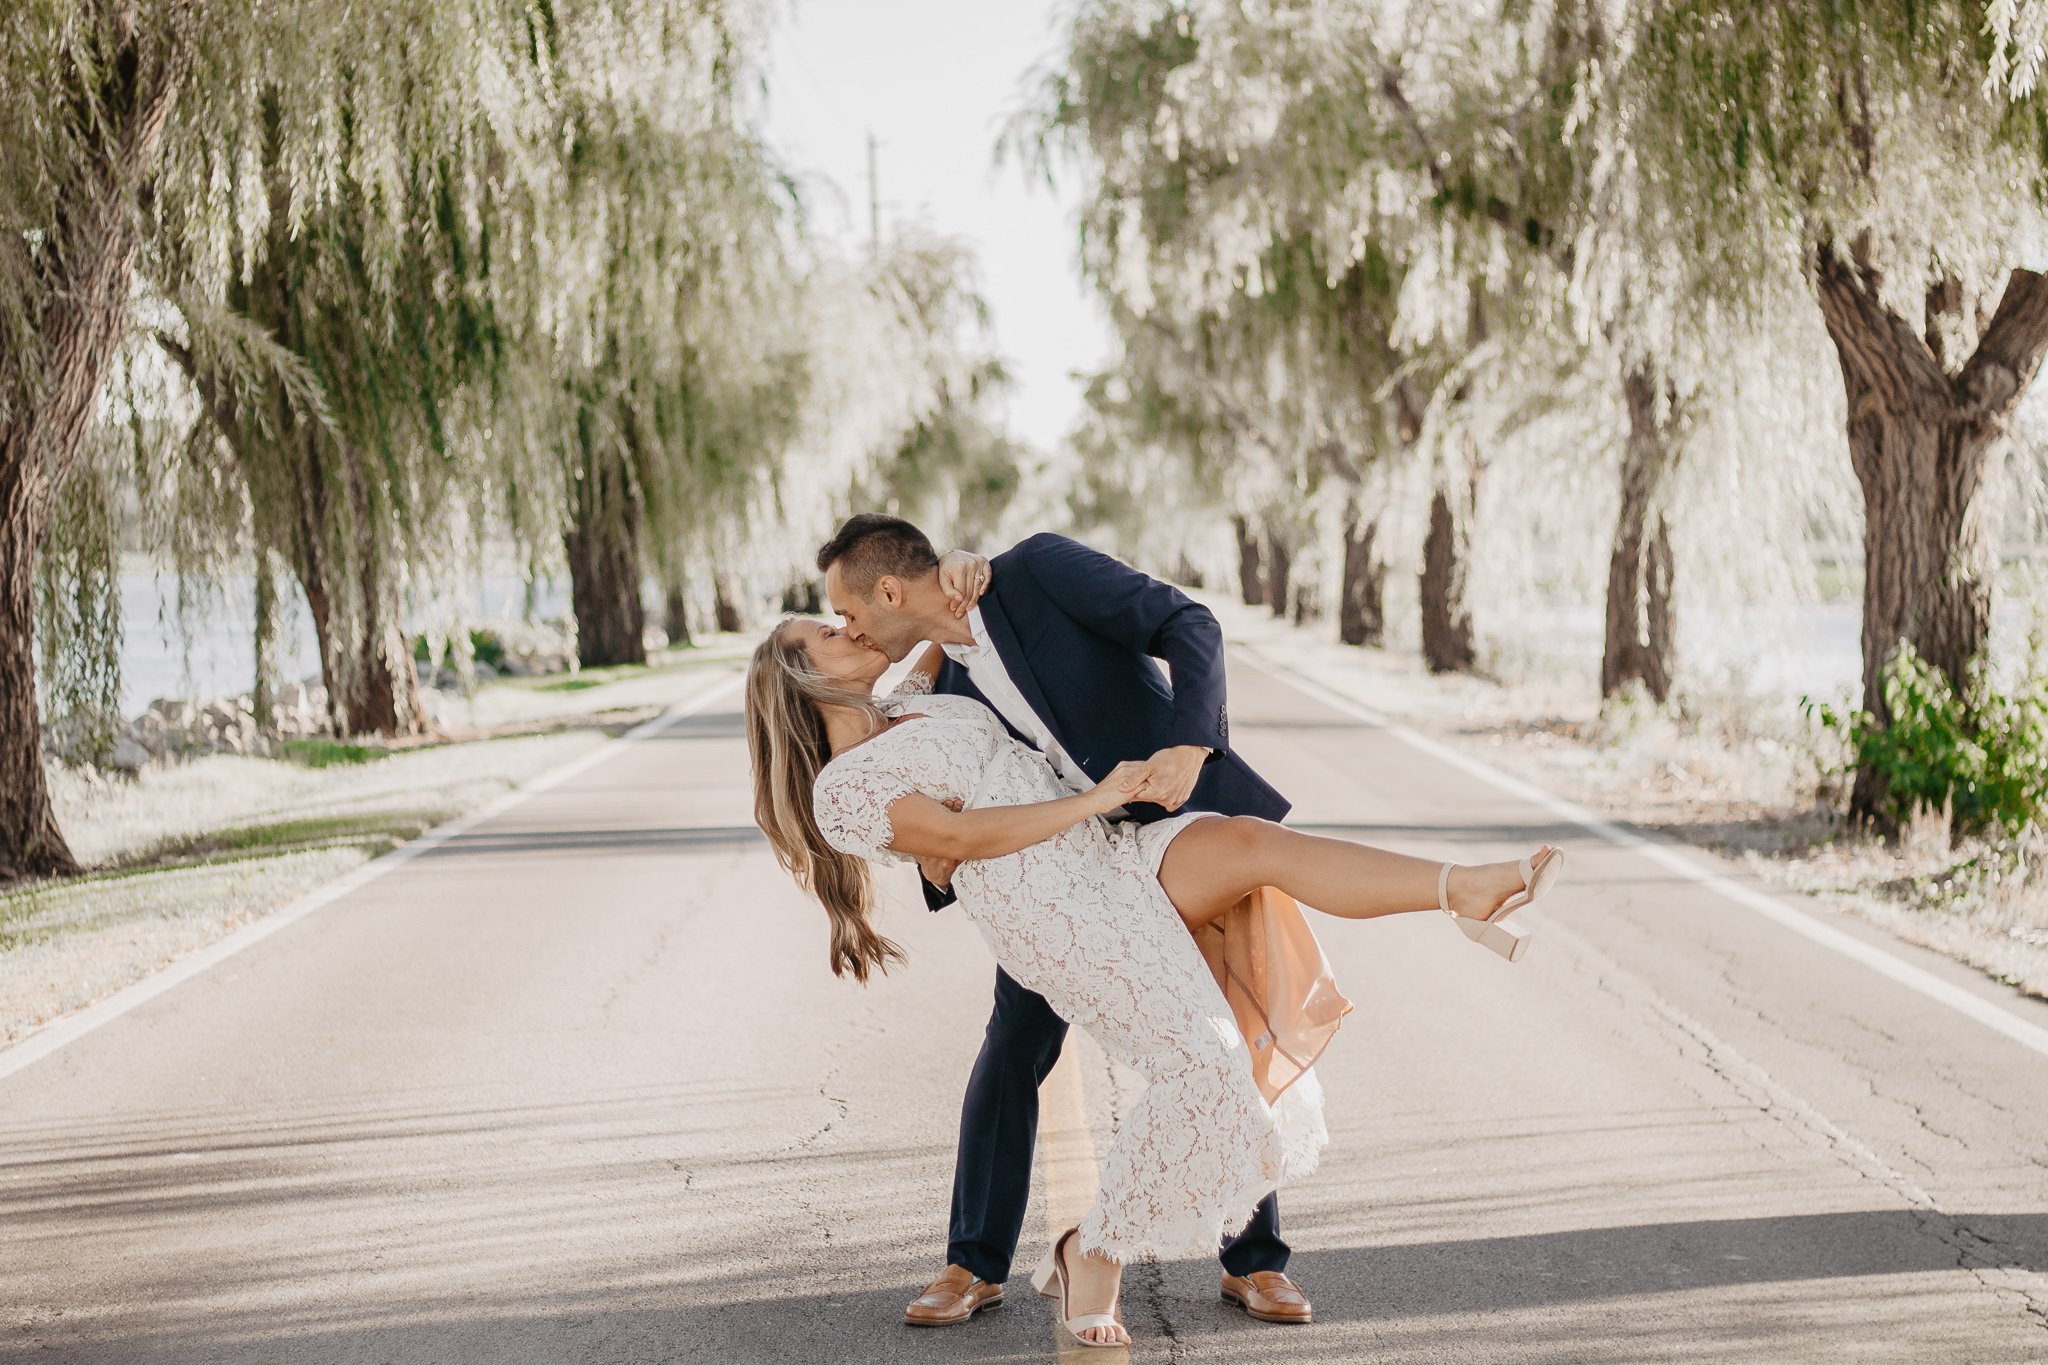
[12,1209,2048,1365]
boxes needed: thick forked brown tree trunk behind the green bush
[1817,239,2048,829]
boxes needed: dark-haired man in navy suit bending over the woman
[817,514,1311,1326]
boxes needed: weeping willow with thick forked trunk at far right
[1583,0,2048,819]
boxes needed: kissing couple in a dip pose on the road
[745,514,1563,1347]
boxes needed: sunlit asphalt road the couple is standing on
[0,659,2048,1365]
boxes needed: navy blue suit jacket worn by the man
[926,532,1288,909]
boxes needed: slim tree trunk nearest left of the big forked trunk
[1599,364,1673,706]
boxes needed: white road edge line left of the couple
[0,675,743,1078]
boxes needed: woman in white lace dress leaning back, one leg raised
[748,618,1563,1347]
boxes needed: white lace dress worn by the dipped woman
[813,673,1329,1263]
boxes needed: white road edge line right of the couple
[1237,643,2048,1056]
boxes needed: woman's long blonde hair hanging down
[748,616,907,984]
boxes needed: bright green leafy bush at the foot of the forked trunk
[1802,645,2048,837]
